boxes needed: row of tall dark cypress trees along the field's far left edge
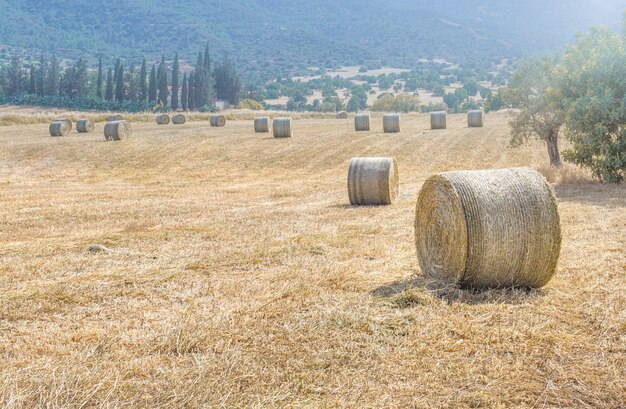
[0,45,241,110]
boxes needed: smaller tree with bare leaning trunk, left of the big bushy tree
[503,57,563,167]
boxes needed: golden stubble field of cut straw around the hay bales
[0,110,626,408]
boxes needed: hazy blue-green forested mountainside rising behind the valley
[0,0,624,77]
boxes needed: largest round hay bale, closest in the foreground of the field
[415,168,561,288]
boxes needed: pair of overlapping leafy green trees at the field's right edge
[502,14,626,182]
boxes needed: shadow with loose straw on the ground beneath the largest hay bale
[371,274,544,308]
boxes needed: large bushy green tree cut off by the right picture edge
[549,28,626,183]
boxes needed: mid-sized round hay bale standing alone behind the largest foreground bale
[348,158,399,205]
